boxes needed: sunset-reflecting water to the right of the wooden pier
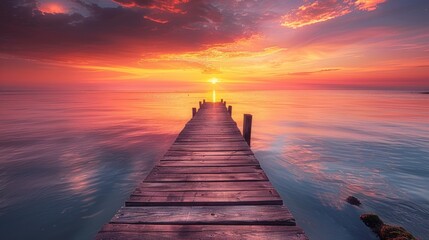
[223,91,429,239]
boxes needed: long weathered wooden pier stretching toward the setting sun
[96,101,307,240]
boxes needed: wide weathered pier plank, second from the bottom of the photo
[111,206,296,226]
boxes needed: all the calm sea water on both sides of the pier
[0,91,429,240]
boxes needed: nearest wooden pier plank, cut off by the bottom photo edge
[96,224,308,240]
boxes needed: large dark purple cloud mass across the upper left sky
[0,0,266,61]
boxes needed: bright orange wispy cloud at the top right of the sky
[281,0,387,29]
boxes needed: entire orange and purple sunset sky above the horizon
[0,0,429,91]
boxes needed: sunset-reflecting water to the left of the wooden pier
[0,92,204,239]
